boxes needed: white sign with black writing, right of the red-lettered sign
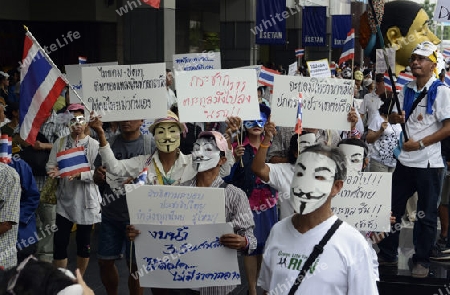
[271,75,354,131]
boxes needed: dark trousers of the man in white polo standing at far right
[378,161,444,267]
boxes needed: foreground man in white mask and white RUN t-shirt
[259,144,378,295]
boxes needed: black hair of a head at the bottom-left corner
[0,260,75,295]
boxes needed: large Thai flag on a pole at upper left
[19,32,66,145]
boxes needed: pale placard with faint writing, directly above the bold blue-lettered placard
[125,184,225,225]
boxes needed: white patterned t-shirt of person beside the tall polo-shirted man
[369,114,402,167]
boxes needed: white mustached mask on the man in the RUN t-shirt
[290,152,336,215]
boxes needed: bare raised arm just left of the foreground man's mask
[252,121,277,182]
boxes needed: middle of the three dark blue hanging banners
[302,6,327,47]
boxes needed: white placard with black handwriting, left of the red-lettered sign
[81,63,167,122]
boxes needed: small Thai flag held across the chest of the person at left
[56,146,91,177]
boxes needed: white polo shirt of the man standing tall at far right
[393,77,450,168]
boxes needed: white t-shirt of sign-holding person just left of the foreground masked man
[266,163,294,219]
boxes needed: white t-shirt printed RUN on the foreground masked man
[258,215,378,295]
